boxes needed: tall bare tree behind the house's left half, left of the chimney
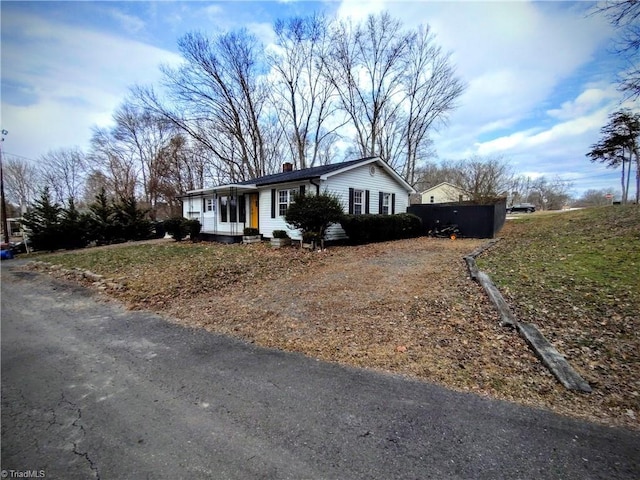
[134,30,277,181]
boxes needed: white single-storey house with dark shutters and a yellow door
[181,157,415,242]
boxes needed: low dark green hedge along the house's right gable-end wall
[340,213,422,244]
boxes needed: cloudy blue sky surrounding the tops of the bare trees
[0,0,638,195]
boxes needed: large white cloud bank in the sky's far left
[2,9,180,158]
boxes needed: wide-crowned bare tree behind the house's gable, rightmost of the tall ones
[324,13,464,184]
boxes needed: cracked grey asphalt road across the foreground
[1,262,640,480]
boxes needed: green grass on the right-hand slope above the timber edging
[478,206,640,315]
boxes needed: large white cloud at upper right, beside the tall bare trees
[332,0,610,142]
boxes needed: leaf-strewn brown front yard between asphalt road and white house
[28,204,640,429]
